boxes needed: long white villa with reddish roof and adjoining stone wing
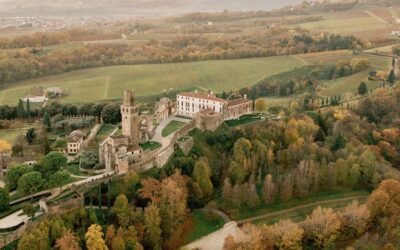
[176,91,253,120]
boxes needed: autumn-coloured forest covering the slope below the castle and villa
[10,87,400,250]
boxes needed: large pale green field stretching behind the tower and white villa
[0,56,304,105]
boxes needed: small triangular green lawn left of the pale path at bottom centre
[185,211,224,243]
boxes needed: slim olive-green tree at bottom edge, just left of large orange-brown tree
[144,204,162,250]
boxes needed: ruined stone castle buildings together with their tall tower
[99,90,154,171]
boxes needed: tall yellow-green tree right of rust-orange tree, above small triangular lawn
[193,158,214,198]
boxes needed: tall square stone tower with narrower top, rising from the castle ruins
[121,90,140,144]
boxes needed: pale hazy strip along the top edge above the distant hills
[0,0,302,16]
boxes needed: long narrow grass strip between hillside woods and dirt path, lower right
[218,190,369,220]
